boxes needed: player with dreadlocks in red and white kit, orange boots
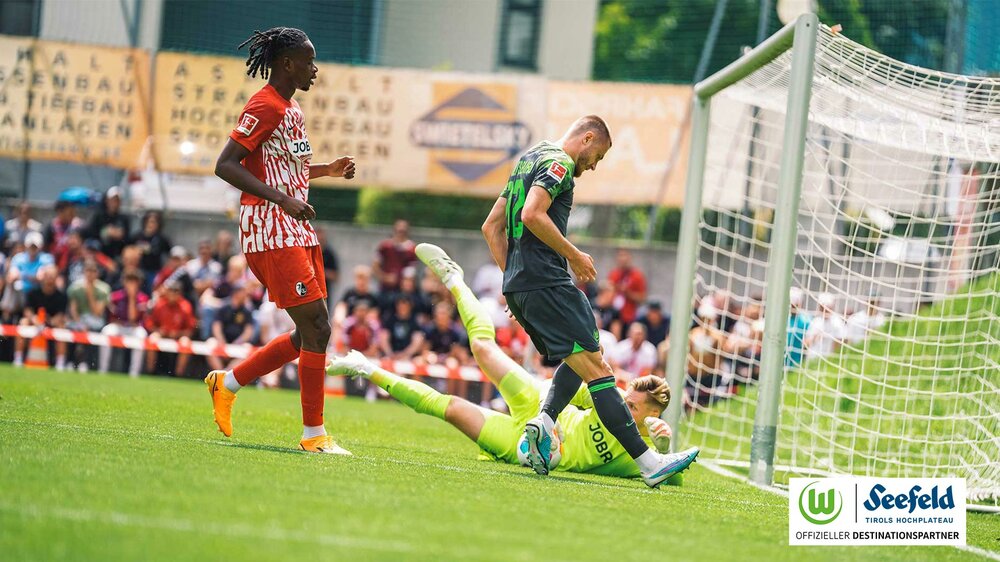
[205,27,355,455]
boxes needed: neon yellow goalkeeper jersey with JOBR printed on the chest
[556,385,639,478]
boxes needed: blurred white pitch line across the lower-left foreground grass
[0,503,413,552]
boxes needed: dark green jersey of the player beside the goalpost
[501,141,574,293]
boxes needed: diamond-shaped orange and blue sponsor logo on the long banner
[410,82,532,185]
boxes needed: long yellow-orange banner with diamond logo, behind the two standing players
[153,53,691,204]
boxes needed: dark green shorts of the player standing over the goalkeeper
[504,285,600,363]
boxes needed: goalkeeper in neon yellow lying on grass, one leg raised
[327,244,697,484]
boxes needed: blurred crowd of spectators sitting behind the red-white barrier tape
[0,195,885,414]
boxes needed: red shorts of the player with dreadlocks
[245,246,326,308]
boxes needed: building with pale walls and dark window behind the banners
[0,0,598,205]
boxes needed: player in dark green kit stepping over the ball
[483,115,698,487]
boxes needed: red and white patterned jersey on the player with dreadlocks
[229,84,319,254]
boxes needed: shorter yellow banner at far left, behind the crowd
[0,36,150,168]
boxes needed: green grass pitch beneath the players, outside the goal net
[0,365,1000,562]
